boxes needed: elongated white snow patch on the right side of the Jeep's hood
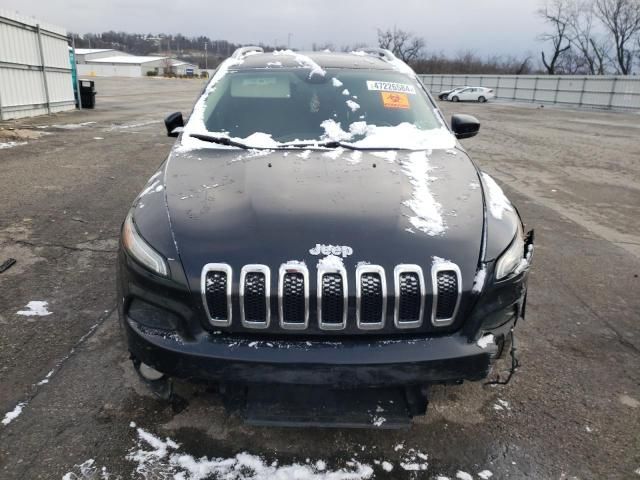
[402,152,446,236]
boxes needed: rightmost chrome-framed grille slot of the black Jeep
[431,262,462,327]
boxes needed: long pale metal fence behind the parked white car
[420,75,640,110]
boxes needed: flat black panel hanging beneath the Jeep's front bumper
[220,384,428,429]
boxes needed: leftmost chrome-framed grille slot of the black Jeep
[200,263,233,327]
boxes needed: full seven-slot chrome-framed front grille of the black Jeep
[201,261,462,331]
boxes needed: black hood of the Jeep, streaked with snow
[165,148,484,291]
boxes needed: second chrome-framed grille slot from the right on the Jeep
[393,265,425,328]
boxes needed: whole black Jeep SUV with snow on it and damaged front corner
[118,47,533,424]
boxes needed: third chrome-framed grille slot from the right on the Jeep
[356,265,387,330]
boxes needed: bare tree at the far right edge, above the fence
[595,0,640,75]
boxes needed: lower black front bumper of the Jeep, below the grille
[123,318,497,388]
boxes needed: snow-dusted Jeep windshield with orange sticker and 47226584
[187,64,453,148]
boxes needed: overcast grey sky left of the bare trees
[2,0,544,56]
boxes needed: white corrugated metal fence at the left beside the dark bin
[0,10,75,120]
